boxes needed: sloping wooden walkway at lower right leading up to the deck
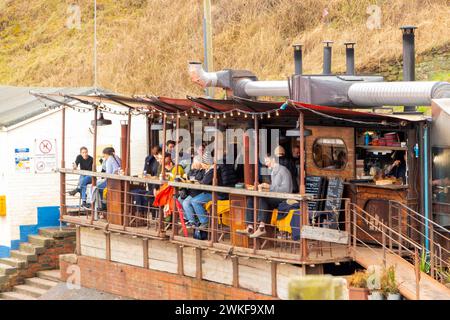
[354,247,450,300]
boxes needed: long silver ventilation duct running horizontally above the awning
[189,62,450,108]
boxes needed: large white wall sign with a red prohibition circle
[34,139,58,173]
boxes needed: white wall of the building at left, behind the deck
[0,109,147,241]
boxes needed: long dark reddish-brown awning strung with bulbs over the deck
[29,93,425,125]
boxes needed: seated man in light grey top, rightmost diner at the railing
[236,155,293,238]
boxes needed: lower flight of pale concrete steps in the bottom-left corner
[0,270,60,300]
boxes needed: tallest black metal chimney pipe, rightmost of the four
[400,26,417,111]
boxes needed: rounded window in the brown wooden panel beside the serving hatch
[313,138,347,170]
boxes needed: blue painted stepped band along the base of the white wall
[0,206,59,258]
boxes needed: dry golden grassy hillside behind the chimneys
[0,0,450,97]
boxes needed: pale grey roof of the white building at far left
[0,86,106,128]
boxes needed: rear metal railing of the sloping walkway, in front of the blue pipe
[388,200,450,282]
